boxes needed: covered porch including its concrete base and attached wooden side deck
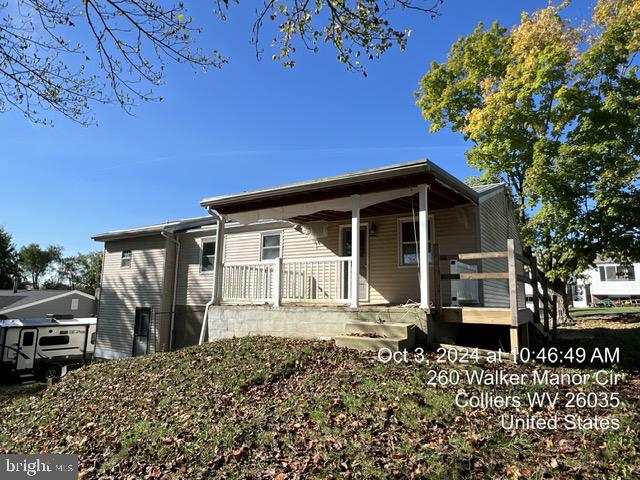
[201,161,544,349]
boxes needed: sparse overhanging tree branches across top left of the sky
[0,0,443,124]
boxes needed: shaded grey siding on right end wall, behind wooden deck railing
[479,189,524,307]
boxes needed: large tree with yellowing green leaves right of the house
[418,0,640,317]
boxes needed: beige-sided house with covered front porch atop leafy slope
[93,160,539,358]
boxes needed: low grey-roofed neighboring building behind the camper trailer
[0,290,97,320]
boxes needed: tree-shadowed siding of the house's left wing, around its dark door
[96,235,166,357]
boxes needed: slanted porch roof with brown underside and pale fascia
[201,159,478,222]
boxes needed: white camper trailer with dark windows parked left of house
[0,317,97,379]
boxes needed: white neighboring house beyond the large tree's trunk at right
[570,260,640,308]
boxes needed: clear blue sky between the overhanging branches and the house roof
[0,0,593,255]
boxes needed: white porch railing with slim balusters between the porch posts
[222,257,352,305]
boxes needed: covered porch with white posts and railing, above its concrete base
[202,161,479,310]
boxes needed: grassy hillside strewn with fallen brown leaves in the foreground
[0,338,640,480]
